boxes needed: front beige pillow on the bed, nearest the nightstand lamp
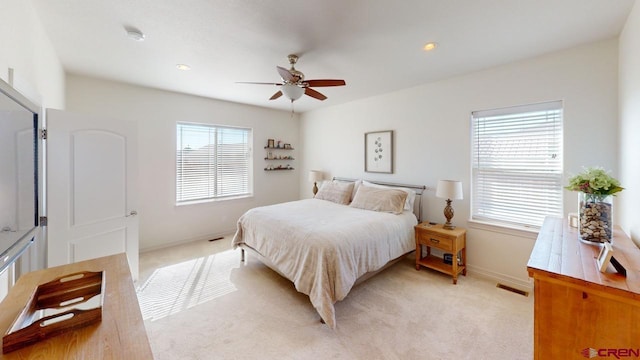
[349,185,407,214]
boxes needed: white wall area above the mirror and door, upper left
[0,0,64,109]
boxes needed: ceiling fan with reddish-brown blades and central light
[239,54,346,102]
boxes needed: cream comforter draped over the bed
[233,199,417,328]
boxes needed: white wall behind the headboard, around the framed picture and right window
[300,39,618,287]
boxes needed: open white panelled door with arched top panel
[46,109,138,280]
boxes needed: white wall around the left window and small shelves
[67,75,299,251]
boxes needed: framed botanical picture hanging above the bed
[364,130,393,174]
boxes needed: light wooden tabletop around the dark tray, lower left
[0,253,153,360]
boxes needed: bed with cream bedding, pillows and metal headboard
[232,178,425,329]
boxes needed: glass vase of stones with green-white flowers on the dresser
[565,167,624,244]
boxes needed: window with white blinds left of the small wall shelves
[176,123,252,203]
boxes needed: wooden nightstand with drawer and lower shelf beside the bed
[415,223,467,284]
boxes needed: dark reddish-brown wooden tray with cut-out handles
[2,271,105,354]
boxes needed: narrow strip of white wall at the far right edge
[618,2,640,244]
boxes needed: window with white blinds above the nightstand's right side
[471,101,562,227]
